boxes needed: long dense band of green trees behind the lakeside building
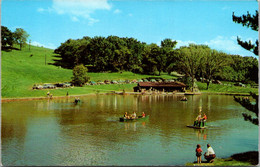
[54,36,258,83]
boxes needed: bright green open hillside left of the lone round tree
[1,46,72,97]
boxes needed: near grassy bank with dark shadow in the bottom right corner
[186,151,259,166]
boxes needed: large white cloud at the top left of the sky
[37,0,112,24]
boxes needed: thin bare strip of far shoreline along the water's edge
[1,91,252,102]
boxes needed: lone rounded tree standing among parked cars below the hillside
[72,64,90,86]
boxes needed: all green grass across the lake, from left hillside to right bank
[1,46,258,98]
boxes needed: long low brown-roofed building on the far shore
[134,82,187,92]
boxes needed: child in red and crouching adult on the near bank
[195,144,216,163]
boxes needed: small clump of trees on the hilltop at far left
[1,26,29,50]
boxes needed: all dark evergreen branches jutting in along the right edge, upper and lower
[233,8,259,125]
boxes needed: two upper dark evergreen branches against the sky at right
[232,10,258,55]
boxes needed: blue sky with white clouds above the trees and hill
[1,0,258,56]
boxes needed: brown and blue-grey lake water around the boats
[1,95,258,166]
